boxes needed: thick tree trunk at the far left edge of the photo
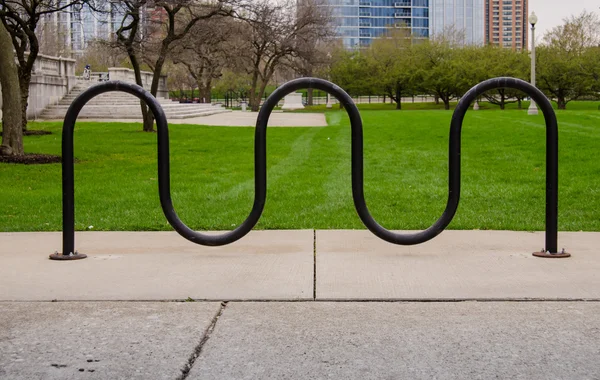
[0,23,27,156]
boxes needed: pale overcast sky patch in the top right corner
[529,0,600,41]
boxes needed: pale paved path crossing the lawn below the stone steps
[41,111,327,127]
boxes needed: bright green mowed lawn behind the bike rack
[0,110,600,231]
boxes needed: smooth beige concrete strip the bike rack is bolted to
[0,230,600,301]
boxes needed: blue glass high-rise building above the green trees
[327,0,430,49]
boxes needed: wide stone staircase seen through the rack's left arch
[39,81,231,120]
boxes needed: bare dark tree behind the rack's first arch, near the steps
[116,0,234,132]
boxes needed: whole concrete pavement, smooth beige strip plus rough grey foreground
[0,230,600,379]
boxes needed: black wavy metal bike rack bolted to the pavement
[50,78,569,260]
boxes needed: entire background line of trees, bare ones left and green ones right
[0,0,600,155]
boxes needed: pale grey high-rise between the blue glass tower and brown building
[429,0,486,45]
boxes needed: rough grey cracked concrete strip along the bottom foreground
[0,302,600,380]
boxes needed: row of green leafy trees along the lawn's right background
[329,12,600,109]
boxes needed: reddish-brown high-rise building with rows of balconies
[485,0,529,50]
